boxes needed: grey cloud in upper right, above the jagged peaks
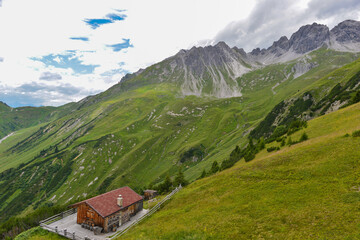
[209,0,360,51]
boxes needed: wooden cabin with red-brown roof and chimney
[70,187,143,232]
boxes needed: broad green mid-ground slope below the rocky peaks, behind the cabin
[0,49,356,227]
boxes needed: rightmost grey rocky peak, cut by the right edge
[331,20,360,43]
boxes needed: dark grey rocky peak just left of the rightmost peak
[289,23,330,54]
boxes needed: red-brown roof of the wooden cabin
[74,187,143,217]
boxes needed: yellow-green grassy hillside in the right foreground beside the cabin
[121,104,360,239]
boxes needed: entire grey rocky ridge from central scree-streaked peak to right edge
[120,20,360,98]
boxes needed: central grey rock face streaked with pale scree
[158,42,252,98]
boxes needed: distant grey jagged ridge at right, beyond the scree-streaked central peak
[247,20,360,65]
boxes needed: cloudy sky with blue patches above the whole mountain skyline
[0,0,360,107]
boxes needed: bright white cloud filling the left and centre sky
[0,0,253,106]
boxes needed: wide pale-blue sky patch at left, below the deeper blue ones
[31,51,100,74]
